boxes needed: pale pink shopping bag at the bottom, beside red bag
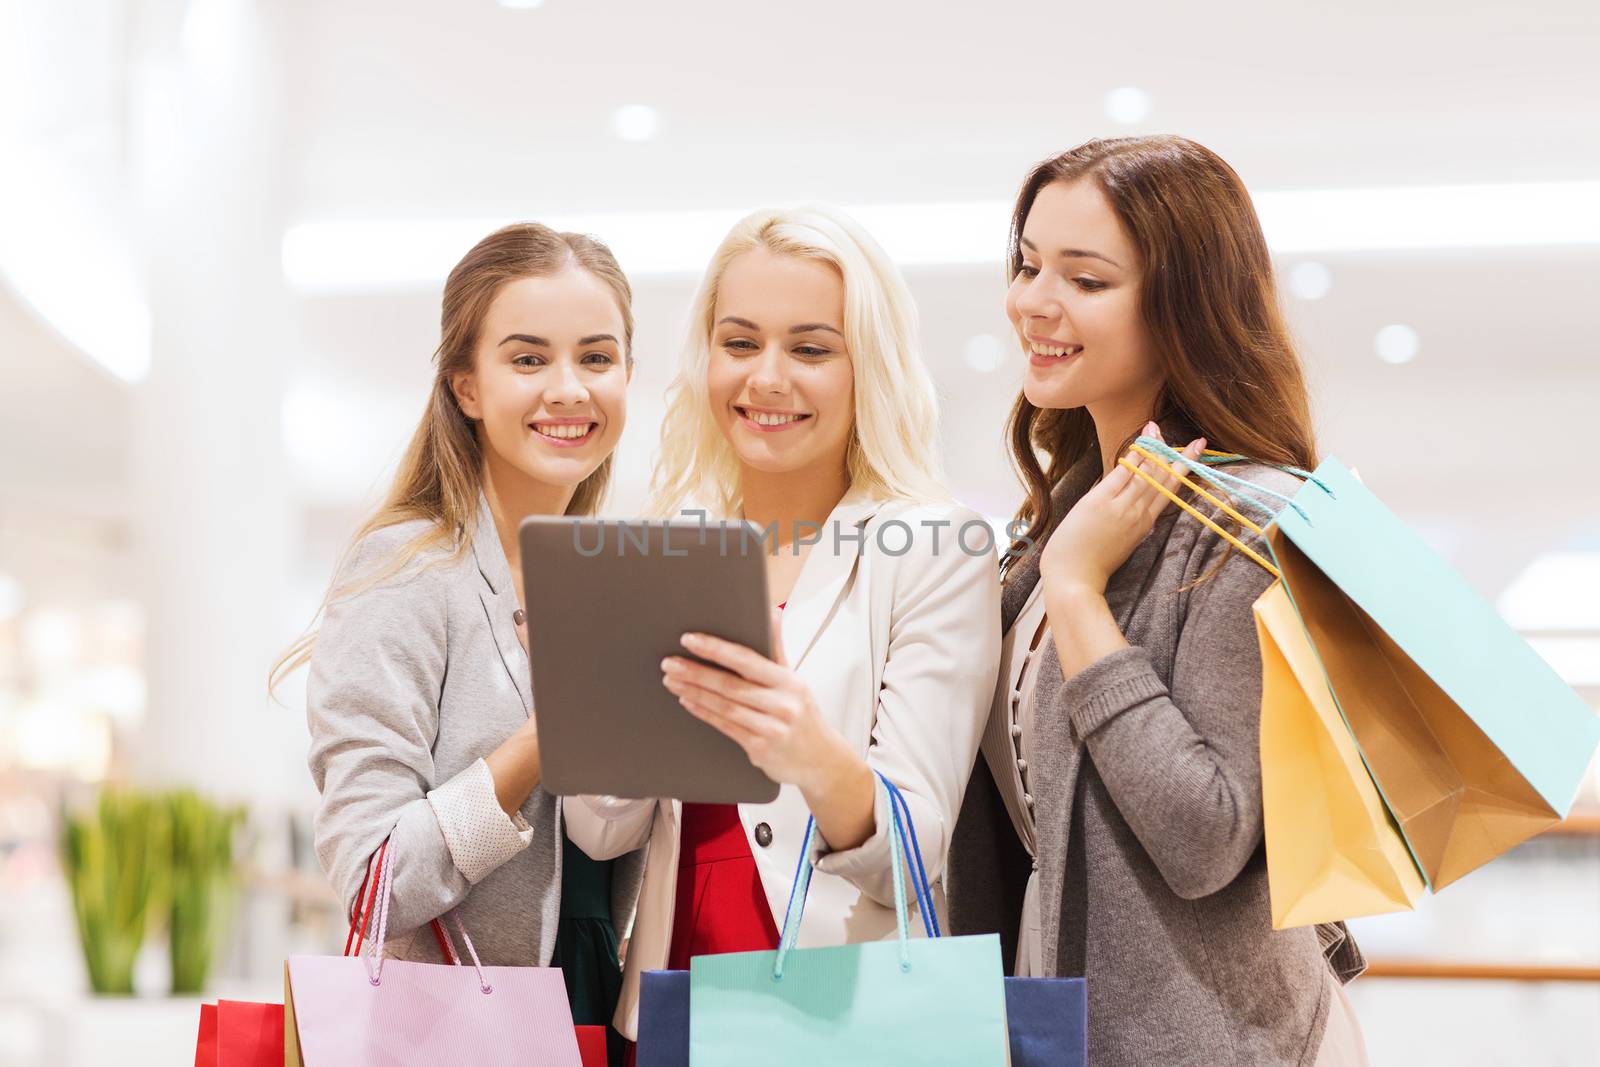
[283,843,582,1067]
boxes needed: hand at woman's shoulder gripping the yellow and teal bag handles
[1038,422,1205,595]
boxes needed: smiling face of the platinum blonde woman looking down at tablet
[706,248,856,474]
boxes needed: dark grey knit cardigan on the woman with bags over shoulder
[947,454,1360,1067]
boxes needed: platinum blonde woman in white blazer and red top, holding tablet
[568,210,1000,1037]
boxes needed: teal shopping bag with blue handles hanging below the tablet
[690,776,1008,1067]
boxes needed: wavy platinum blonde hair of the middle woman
[650,206,950,517]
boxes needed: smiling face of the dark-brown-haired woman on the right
[1005,178,1162,422]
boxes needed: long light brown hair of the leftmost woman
[267,222,634,691]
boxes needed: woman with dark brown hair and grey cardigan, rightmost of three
[949,138,1365,1067]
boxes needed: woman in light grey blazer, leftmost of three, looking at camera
[278,224,638,1059]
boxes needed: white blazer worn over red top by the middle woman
[565,490,1000,1038]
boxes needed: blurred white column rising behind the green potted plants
[131,0,314,811]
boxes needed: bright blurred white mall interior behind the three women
[0,0,1600,1067]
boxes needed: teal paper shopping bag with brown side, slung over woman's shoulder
[1139,438,1600,889]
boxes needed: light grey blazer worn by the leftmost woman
[306,498,642,966]
